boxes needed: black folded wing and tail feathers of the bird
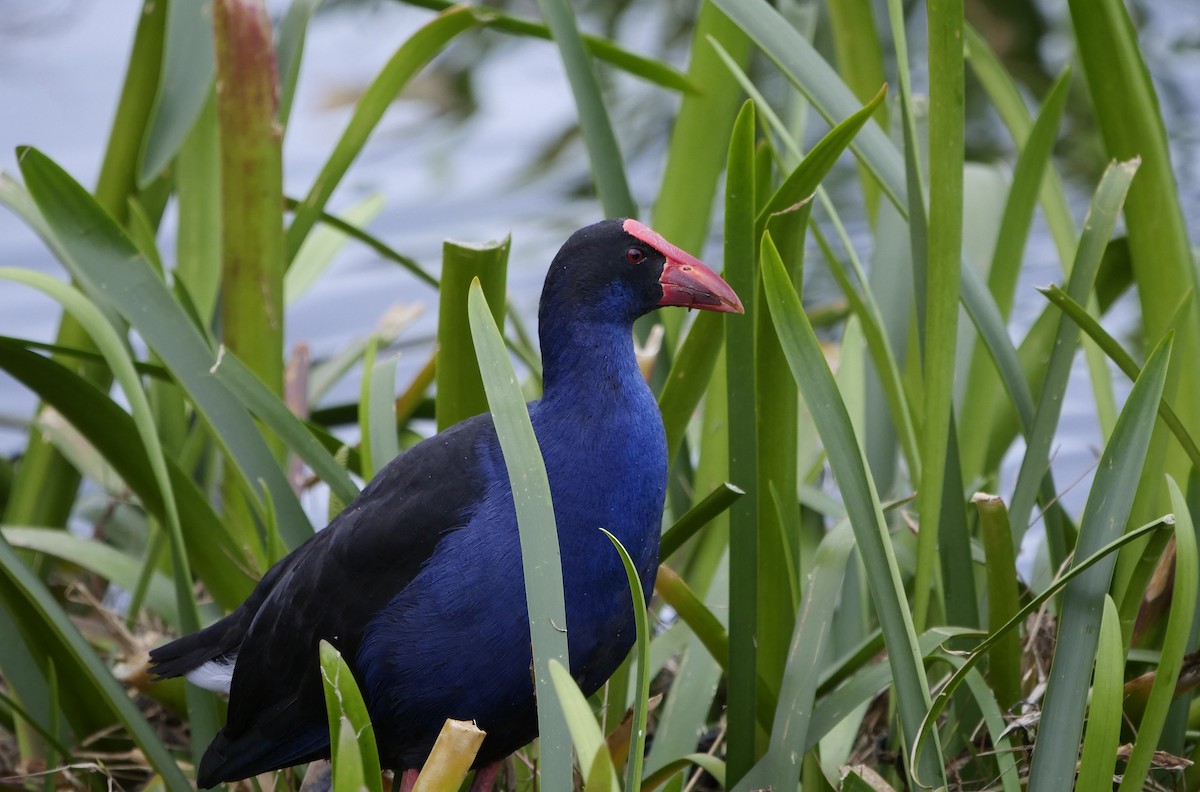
[151,415,496,787]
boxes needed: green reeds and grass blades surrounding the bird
[0,0,1200,792]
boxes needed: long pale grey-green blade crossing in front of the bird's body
[468,282,571,790]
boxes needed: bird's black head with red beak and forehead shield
[541,220,744,323]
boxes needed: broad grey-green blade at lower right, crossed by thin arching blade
[1030,336,1171,792]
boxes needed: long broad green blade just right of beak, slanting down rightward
[762,234,944,778]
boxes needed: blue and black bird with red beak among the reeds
[150,218,744,790]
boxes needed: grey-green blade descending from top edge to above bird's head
[538,0,637,217]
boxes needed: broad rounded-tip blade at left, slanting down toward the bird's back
[20,148,312,546]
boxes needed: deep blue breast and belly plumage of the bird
[356,355,667,761]
